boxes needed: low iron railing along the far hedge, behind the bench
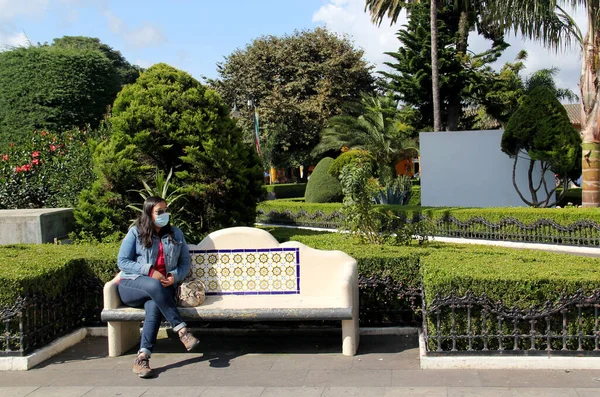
[257,209,600,247]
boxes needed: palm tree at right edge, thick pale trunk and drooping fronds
[489,0,600,207]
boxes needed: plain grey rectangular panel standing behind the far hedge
[419,130,554,207]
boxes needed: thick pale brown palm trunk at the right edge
[580,14,600,207]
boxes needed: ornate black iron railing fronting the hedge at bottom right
[423,290,600,356]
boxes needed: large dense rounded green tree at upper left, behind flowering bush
[0,38,134,147]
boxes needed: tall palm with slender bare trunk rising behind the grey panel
[365,0,442,131]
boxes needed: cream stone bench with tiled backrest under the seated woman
[102,227,359,356]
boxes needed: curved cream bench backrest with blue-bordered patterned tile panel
[188,227,356,296]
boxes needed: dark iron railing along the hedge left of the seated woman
[0,277,103,356]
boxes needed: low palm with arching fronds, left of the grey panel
[313,95,417,180]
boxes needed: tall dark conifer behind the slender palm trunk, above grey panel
[380,3,507,130]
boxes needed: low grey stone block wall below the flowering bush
[0,208,75,245]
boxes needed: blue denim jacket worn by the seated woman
[117,226,191,283]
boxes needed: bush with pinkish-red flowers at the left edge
[0,130,101,209]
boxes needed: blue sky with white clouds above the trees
[0,0,585,103]
